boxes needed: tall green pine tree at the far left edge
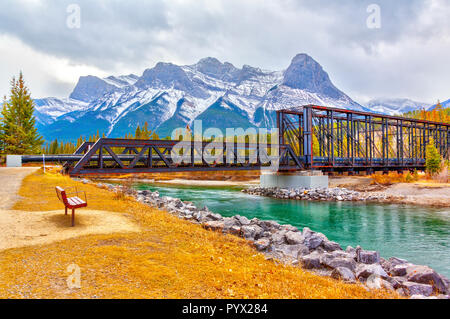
[0,72,44,154]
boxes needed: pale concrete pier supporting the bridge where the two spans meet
[260,171,329,188]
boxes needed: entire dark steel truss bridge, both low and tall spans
[22,105,450,176]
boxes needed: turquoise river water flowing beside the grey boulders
[136,184,450,277]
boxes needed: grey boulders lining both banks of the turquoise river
[92,181,450,299]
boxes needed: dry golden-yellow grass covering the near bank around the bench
[0,171,398,298]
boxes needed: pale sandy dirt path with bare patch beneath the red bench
[0,168,140,250]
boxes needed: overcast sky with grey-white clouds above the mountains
[0,0,450,103]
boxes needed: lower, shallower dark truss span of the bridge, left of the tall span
[66,138,303,176]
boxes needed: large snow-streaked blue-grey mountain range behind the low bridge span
[36,54,368,140]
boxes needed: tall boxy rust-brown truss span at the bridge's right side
[277,105,450,172]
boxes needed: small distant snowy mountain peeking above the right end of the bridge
[367,98,431,115]
